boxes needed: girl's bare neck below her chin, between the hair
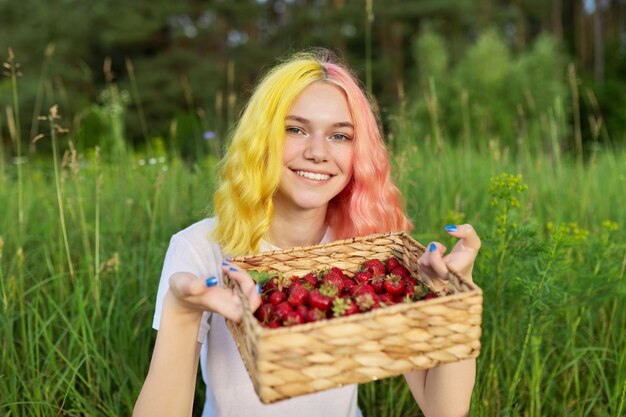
[267,206,327,249]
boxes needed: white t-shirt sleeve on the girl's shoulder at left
[152,234,216,343]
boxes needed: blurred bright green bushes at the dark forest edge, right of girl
[412,29,570,150]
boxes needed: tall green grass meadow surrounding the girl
[0,61,626,417]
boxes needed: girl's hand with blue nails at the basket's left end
[169,263,261,322]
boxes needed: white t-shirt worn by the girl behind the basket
[152,218,361,417]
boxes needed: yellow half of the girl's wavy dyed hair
[214,53,326,256]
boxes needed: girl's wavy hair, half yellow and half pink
[214,50,413,255]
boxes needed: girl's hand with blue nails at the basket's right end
[417,224,480,291]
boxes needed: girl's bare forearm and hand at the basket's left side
[133,265,261,417]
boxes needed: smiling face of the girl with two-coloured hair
[274,82,355,214]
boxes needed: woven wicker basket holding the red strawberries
[226,233,482,403]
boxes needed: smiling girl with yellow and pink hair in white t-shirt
[134,51,480,417]
